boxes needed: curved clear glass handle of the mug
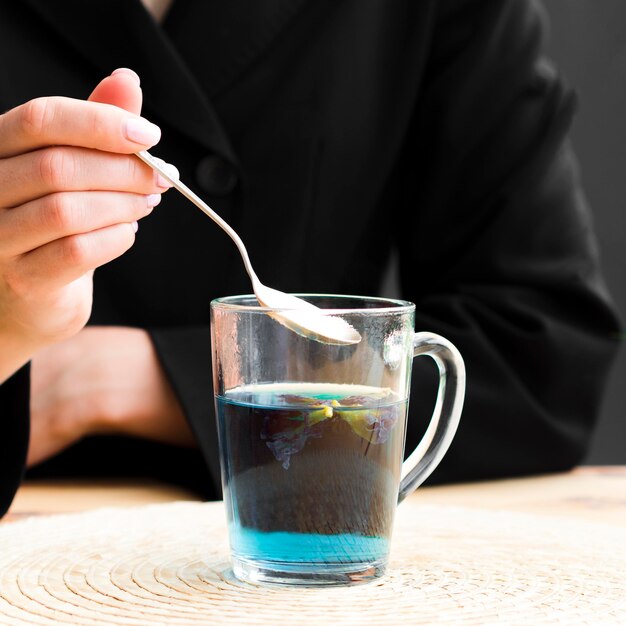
[398,332,465,502]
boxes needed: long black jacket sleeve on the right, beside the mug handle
[398,0,619,482]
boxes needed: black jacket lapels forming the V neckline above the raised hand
[23,0,310,165]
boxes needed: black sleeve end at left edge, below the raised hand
[0,365,30,517]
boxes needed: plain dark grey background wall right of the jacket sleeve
[544,0,626,464]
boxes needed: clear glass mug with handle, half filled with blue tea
[211,295,465,585]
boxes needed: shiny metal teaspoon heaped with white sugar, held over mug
[136,150,361,345]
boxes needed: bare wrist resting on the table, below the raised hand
[27,326,195,466]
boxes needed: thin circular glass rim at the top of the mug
[211,293,415,316]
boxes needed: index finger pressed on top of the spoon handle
[0,96,161,158]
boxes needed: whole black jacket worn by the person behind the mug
[0,0,618,509]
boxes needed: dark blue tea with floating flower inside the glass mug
[217,383,406,571]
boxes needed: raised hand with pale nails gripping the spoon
[0,70,169,383]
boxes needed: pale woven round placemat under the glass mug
[0,501,626,626]
